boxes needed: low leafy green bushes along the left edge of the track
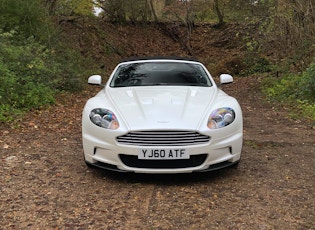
[0,28,89,122]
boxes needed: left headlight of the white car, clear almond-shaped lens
[90,108,119,129]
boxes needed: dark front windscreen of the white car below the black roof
[110,62,212,87]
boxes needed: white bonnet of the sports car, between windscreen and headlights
[107,86,217,130]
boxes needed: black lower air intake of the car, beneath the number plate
[119,154,208,169]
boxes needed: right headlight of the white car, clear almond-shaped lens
[208,107,235,129]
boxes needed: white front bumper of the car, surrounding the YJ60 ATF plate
[83,132,243,174]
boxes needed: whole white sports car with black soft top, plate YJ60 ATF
[82,58,243,174]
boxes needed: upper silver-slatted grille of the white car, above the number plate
[117,131,210,146]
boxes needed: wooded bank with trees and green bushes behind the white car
[0,0,315,124]
